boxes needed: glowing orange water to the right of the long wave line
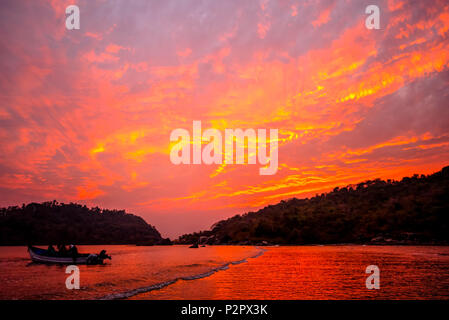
[134,246,449,299]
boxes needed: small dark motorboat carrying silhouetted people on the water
[28,246,111,265]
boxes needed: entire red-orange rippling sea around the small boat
[0,245,449,299]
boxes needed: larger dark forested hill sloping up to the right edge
[177,167,449,244]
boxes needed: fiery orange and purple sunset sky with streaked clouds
[0,0,449,238]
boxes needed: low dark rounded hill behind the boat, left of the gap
[0,201,169,245]
